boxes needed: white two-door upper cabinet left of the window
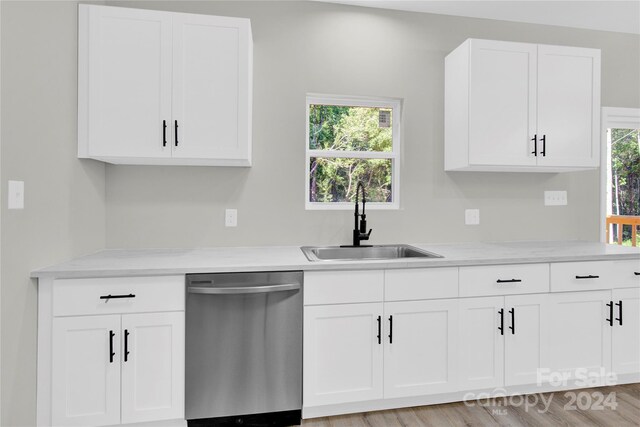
[78,5,253,166]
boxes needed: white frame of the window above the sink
[304,93,402,210]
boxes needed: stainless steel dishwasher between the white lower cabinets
[185,271,303,427]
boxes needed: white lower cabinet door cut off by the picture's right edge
[611,288,640,374]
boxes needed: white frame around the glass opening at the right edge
[600,107,640,242]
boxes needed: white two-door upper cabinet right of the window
[445,39,600,172]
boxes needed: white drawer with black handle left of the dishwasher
[53,276,185,316]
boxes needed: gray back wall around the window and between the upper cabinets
[106,1,640,247]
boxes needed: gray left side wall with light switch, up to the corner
[0,1,105,426]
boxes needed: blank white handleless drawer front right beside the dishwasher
[304,270,384,305]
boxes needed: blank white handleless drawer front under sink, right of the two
[384,267,458,301]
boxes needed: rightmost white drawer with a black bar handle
[551,261,621,292]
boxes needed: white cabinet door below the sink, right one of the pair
[383,300,458,398]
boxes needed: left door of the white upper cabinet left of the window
[87,6,171,158]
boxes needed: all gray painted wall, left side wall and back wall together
[0,1,640,426]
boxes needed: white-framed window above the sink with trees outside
[305,95,400,209]
